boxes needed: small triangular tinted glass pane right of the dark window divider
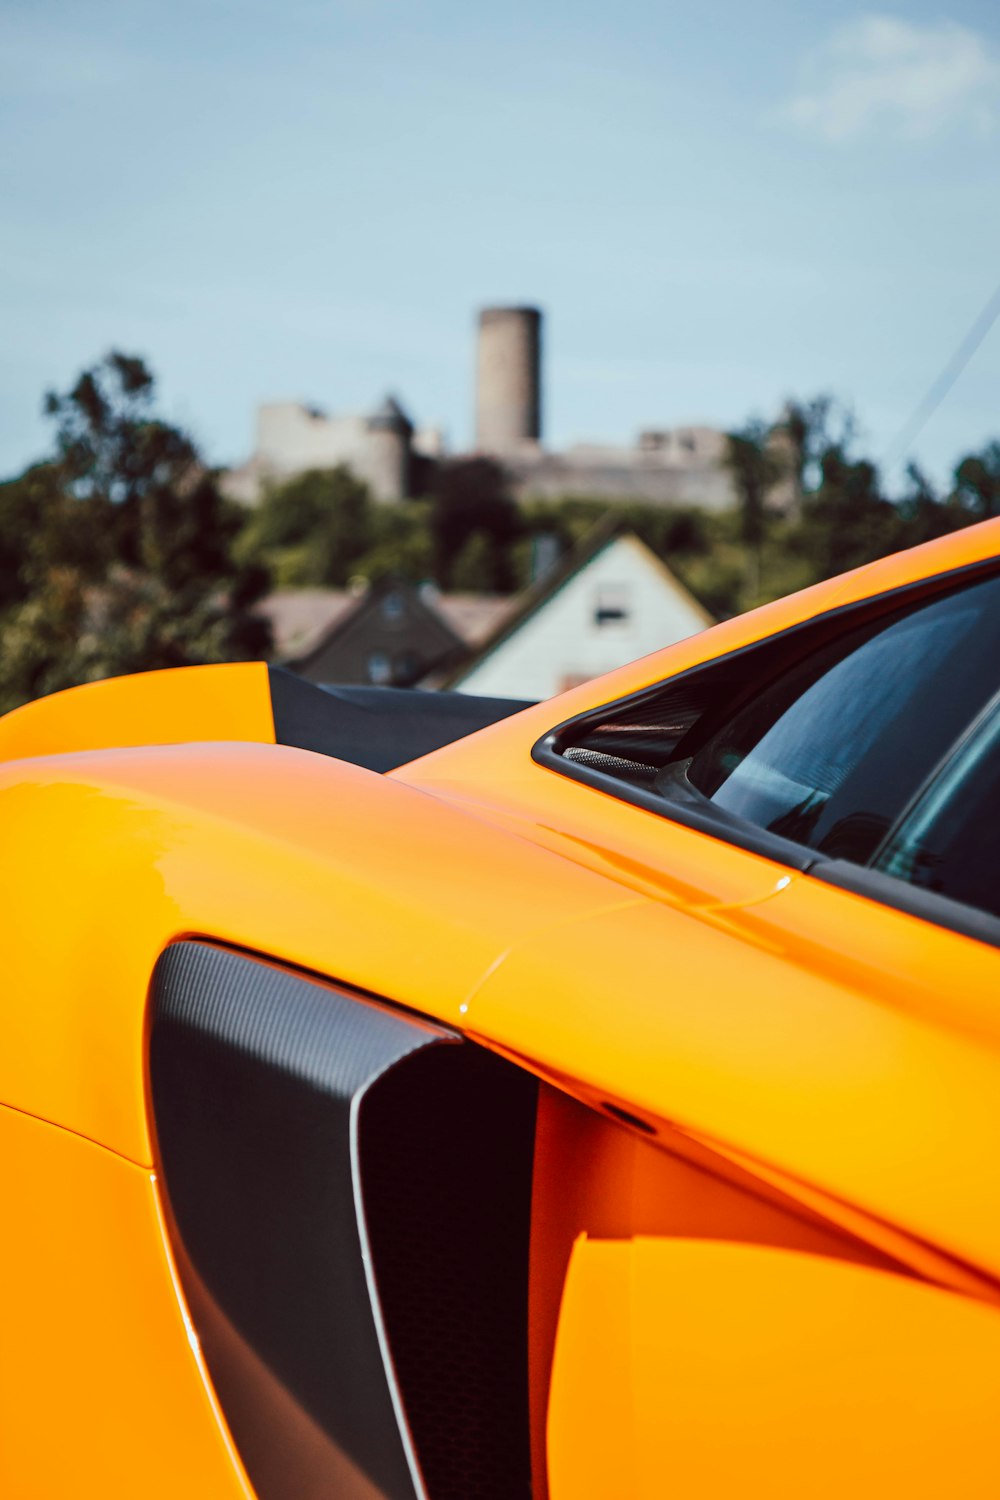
[874,705,1000,917]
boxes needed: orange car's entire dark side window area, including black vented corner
[542,570,1000,942]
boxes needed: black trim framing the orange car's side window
[531,555,1000,947]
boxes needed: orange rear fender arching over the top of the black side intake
[0,744,628,1166]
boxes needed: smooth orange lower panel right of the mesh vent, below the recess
[547,1236,1000,1500]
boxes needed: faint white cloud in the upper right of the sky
[783,15,1000,143]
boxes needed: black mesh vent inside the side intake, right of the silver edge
[360,1046,537,1500]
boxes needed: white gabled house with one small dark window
[445,525,715,699]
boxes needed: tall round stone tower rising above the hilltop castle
[475,308,541,456]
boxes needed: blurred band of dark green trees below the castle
[0,354,1000,711]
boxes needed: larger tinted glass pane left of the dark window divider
[683,578,1000,863]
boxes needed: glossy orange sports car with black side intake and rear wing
[0,522,1000,1500]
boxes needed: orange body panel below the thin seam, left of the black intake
[0,1107,252,1500]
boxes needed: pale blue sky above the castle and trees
[0,0,1000,482]
